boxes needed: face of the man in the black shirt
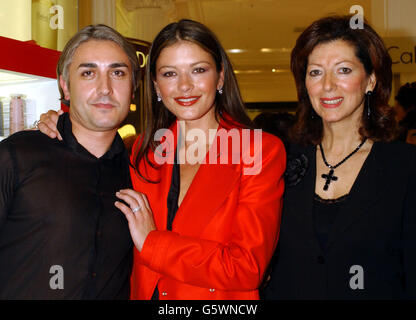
[60,40,132,132]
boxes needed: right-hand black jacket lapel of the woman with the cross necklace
[327,142,386,248]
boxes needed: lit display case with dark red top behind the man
[0,37,61,140]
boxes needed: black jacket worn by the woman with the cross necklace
[265,142,416,299]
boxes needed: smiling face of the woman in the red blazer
[154,41,224,121]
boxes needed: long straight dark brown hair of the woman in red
[133,19,252,181]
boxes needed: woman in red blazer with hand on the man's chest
[38,20,286,300]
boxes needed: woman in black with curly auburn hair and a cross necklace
[264,17,416,299]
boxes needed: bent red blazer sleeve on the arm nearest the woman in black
[140,134,286,291]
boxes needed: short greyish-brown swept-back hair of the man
[56,24,140,105]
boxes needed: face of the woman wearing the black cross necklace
[305,40,376,123]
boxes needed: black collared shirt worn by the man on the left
[0,114,133,299]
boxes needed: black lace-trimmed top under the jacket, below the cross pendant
[313,194,348,251]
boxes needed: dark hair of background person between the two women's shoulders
[253,112,295,150]
